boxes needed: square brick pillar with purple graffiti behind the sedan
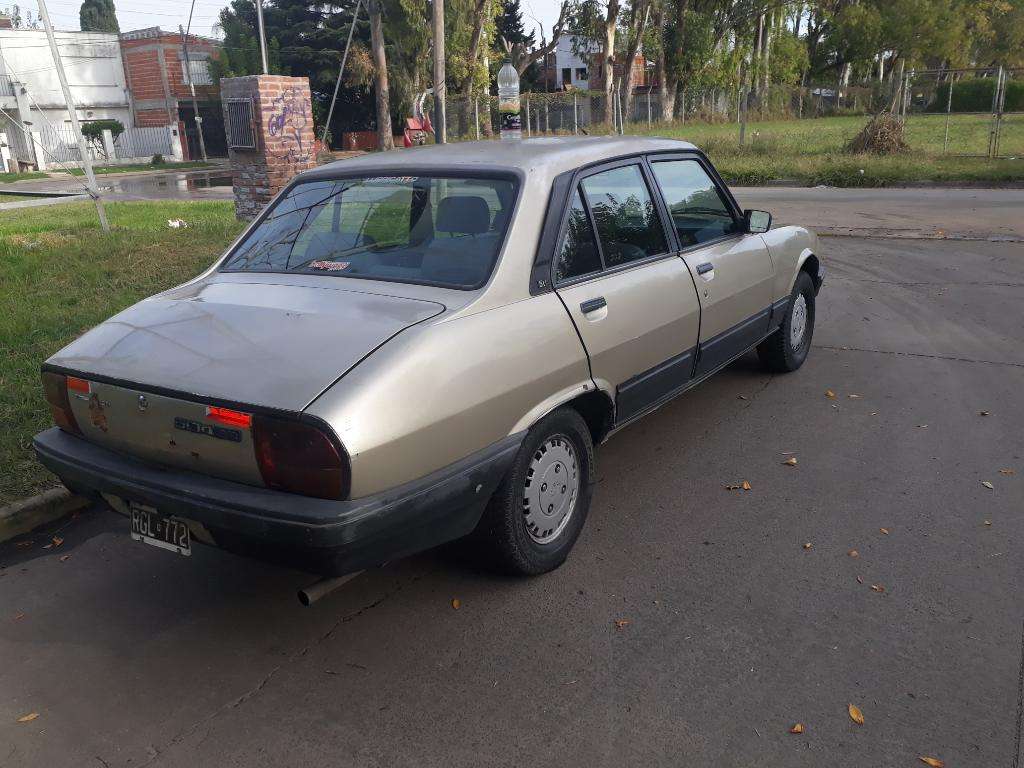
[220,75,316,220]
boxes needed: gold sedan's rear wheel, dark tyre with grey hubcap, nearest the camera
[473,408,594,575]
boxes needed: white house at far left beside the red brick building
[0,29,132,172]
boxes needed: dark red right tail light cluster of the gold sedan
[253,415,349,499]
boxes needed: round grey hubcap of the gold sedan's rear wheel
[522,434,580,544]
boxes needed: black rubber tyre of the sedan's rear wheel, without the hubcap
[469,408,594,575]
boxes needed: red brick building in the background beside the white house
[121,27,227,158]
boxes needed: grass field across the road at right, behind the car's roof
[606,115,1024,186]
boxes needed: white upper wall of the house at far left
[0,30,129,118]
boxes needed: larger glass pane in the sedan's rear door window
[581,165,669,267]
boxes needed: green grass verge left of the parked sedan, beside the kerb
[0,201,242,506]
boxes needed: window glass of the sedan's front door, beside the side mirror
[651,160,739,248]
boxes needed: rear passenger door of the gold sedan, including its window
[553,159,700,422]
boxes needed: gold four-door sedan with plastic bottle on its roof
[35,137,823,574]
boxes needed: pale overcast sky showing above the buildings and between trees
[41,0,559,43]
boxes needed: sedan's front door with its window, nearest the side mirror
[649,155,774,377]
